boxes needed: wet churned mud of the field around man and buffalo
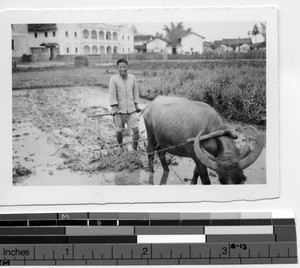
[13,87,266,185]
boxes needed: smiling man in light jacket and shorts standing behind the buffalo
[109,59,141,150]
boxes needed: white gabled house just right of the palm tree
[177,32,205,54]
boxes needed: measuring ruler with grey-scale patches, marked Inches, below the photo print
[0,212,297,265]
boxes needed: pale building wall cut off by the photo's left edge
[11,24,30,58]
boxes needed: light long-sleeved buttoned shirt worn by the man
[109,74,139,114]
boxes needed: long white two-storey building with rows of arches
[28,23,134,59]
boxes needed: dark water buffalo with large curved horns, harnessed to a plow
[143,97,263,184]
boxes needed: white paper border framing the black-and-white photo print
[0,7,280,206]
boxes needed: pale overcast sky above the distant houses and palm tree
[128,21,263,41]
